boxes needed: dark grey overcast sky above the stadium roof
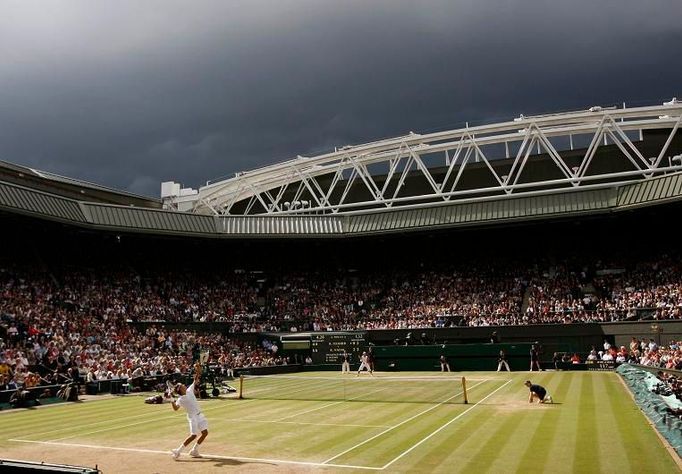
[0,0,682,197]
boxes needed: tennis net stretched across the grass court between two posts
[239,375,467,403]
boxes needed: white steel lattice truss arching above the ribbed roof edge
[171,103,682,215]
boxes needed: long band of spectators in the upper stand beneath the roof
[0,255,682,334]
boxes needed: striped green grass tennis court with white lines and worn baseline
[0,372,680,473]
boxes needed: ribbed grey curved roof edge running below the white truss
[0,172,682,238]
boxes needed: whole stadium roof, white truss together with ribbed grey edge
[0,100,682,238]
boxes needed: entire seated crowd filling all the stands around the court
[0,255,682,388]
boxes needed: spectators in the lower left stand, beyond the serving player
[0,318,287,390]
